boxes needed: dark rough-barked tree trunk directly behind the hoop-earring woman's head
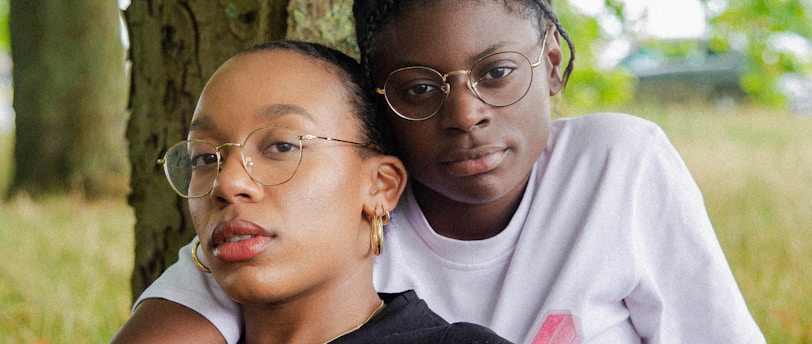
[126,0,287,297]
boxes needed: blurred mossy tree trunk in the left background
[9,0,128,196]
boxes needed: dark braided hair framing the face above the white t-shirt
[352,0,575,86]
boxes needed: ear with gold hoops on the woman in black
[364,155,407,216]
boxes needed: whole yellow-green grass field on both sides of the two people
[0,104,812,343]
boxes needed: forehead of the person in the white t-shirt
[371,1,540,75]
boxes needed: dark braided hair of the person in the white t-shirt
[353,0,575,87]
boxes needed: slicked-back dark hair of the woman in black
[243,40,391,150]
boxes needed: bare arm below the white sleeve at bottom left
[110,299,226,344]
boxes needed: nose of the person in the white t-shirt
[438,74,493,132]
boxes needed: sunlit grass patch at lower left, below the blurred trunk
[0,197,133,343]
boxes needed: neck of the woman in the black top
[242,279,381,343]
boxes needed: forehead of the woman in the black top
[193,49,351,129]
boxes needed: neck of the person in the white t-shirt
[412,175,529,240]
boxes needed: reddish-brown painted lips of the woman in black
[211,219,274,263]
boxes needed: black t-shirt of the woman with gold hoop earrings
[332,290,510,344]
